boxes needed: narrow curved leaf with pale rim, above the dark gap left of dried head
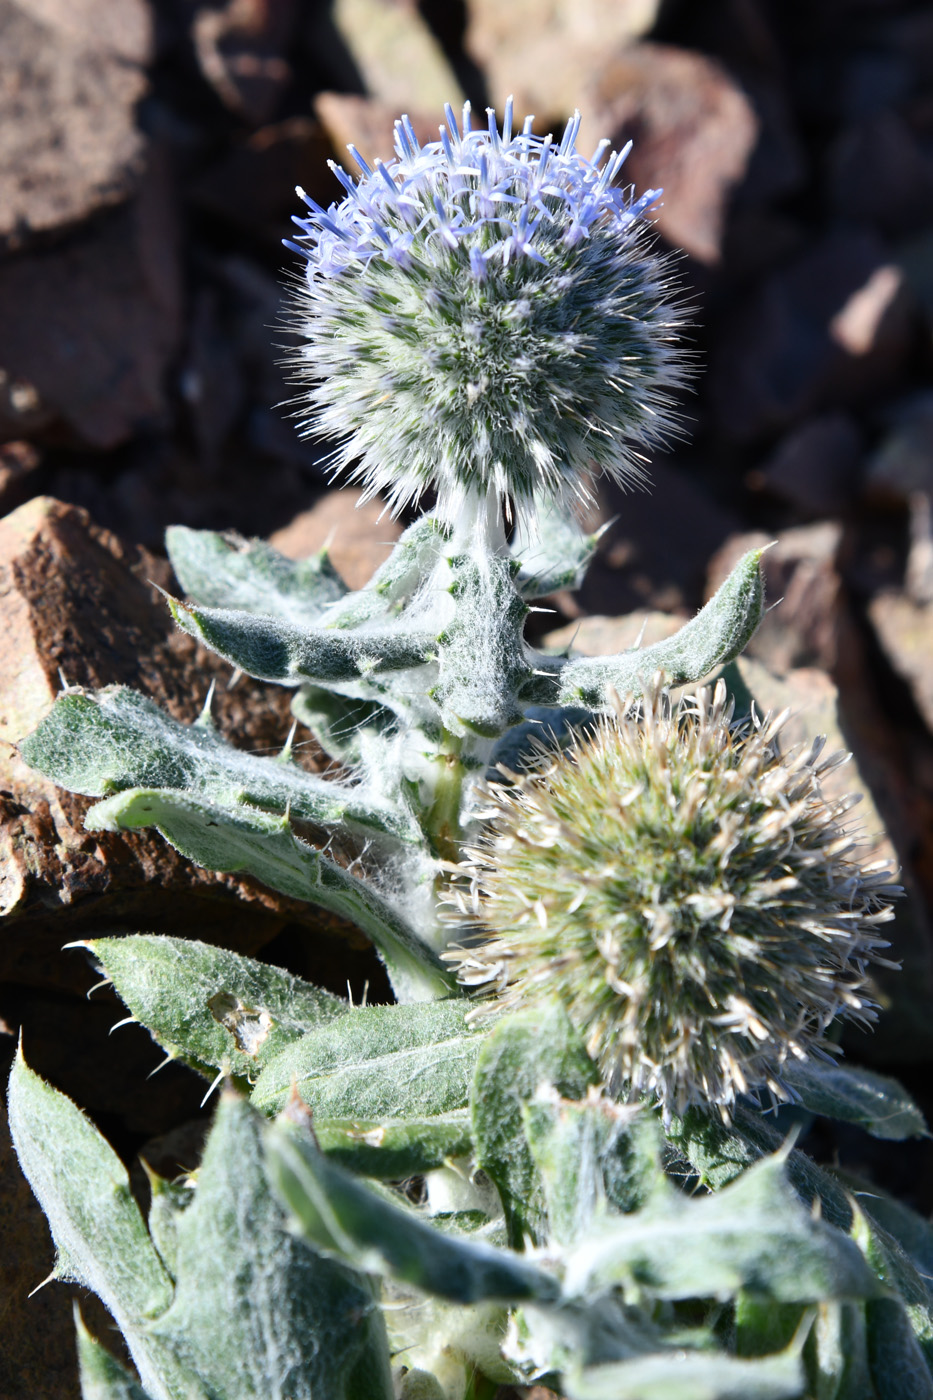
[84,788,452,1001]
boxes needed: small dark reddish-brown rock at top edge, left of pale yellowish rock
[192,0,298,126]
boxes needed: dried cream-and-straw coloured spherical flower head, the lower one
[447,682,899,1119]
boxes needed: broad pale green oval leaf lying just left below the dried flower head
[252,1000,482,1123]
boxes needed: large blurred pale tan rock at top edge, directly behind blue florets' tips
[464,0,661,130]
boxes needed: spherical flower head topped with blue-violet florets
[289,102,685,518]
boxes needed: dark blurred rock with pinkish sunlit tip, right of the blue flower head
[709,230,913,442]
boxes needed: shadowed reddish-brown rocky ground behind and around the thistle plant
[0,0,933,1400]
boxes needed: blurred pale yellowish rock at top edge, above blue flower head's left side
[305,0,464,114]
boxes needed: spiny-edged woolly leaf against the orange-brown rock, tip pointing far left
[20,686,412,839]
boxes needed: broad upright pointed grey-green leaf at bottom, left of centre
[150,1093,392,1400]
